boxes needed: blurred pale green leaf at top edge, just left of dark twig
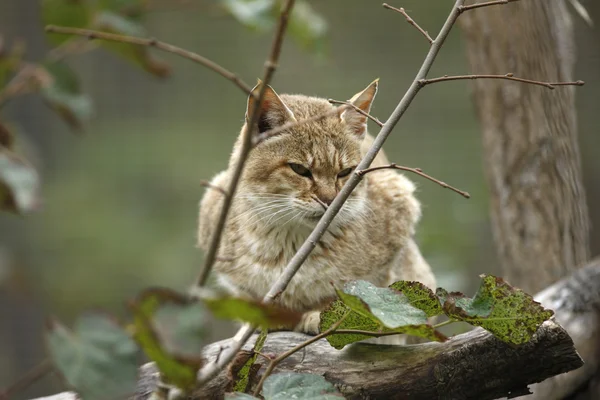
[222,0,277,31]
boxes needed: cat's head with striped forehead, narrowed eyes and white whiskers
[232,81,377,226]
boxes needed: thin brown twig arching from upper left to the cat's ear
[46,25,252,94]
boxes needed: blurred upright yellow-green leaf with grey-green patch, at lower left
[131,289,208,390]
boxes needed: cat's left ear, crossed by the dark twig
[246,80,296,133]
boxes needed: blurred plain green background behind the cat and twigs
[0,0,600,398]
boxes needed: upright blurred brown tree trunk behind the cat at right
[460,0,589,293]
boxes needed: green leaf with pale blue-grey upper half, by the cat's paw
[319,281,446,349]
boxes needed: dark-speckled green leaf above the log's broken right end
[437,275,554,344]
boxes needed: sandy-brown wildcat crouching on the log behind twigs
[198,81,436,334]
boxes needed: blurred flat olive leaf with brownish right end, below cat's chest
[201,296,302,328]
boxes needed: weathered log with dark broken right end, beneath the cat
[135,321,582,400]
